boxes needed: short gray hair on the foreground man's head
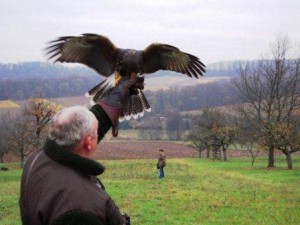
[49,106,97,146]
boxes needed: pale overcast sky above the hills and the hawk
[0,0,300,64]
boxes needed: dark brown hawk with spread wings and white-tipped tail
[46,33,205,119]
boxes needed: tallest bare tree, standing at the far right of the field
[234,36,300,167]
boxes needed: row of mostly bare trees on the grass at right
[187,36,300,169]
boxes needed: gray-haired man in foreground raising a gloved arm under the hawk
[20,75,143,225]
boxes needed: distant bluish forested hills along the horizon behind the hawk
[0,61,240,100]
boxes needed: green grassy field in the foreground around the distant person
[0,156,300,225]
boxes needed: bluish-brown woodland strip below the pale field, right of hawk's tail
[145,81,238,114]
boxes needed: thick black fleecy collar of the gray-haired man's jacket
[44,138,105,176]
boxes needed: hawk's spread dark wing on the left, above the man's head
[46,34,118,77]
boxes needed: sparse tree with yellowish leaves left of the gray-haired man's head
[3,99,60,167]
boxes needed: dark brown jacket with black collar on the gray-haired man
[20,106,126,225]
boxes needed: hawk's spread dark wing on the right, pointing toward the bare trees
[141,43,205,78]
